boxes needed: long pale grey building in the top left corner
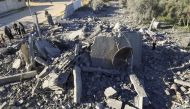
[0,0,26,14]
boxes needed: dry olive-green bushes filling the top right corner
[127,0,190,23]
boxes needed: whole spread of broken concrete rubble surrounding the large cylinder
[0,1,190,109]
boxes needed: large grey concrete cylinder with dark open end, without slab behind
[91,33,132,68]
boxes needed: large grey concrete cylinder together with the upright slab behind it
[91,32,142,69]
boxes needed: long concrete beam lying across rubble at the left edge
[0,70,37,85]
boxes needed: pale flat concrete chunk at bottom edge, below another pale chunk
[106,99,122,109]
